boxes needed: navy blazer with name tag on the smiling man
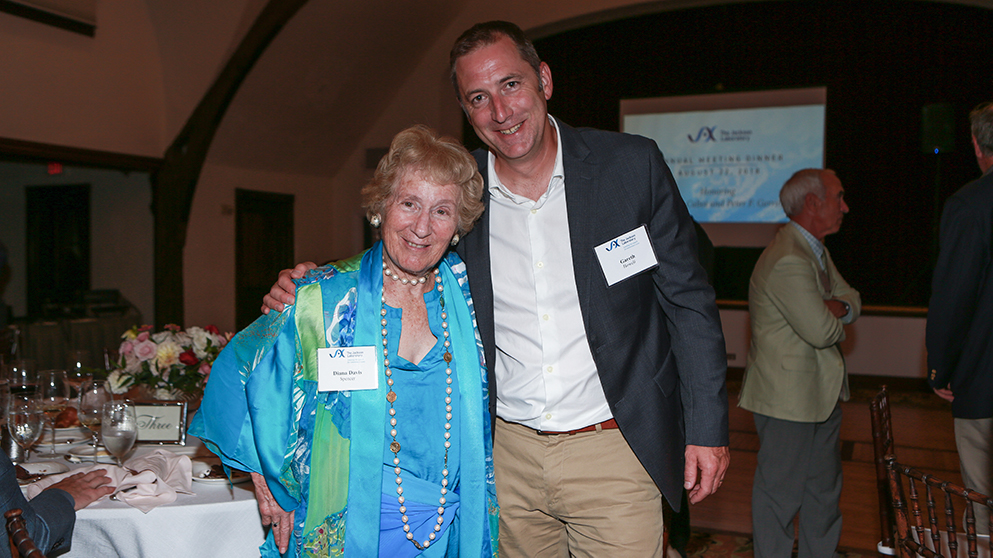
[458,122,728,509]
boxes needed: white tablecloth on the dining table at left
[41,437,265,558]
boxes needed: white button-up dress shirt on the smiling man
[488,116,612,431]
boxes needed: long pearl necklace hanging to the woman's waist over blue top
[380,268,452,550]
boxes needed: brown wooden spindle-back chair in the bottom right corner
[886,455,993,558]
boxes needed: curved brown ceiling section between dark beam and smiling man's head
[204,0,462,176]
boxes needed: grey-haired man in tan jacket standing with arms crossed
[738,169,861,558]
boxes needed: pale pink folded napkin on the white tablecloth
[25,449,193,513]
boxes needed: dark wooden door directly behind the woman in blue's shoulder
[235,188,293,330]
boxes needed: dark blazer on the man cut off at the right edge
[924,169,993,419]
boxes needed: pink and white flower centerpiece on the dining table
[107,324,231,399]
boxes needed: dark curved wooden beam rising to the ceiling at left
[152,0,307,327]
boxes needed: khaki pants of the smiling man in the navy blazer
[493,419,664,558]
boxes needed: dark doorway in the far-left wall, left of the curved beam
[25,184,90,318]
